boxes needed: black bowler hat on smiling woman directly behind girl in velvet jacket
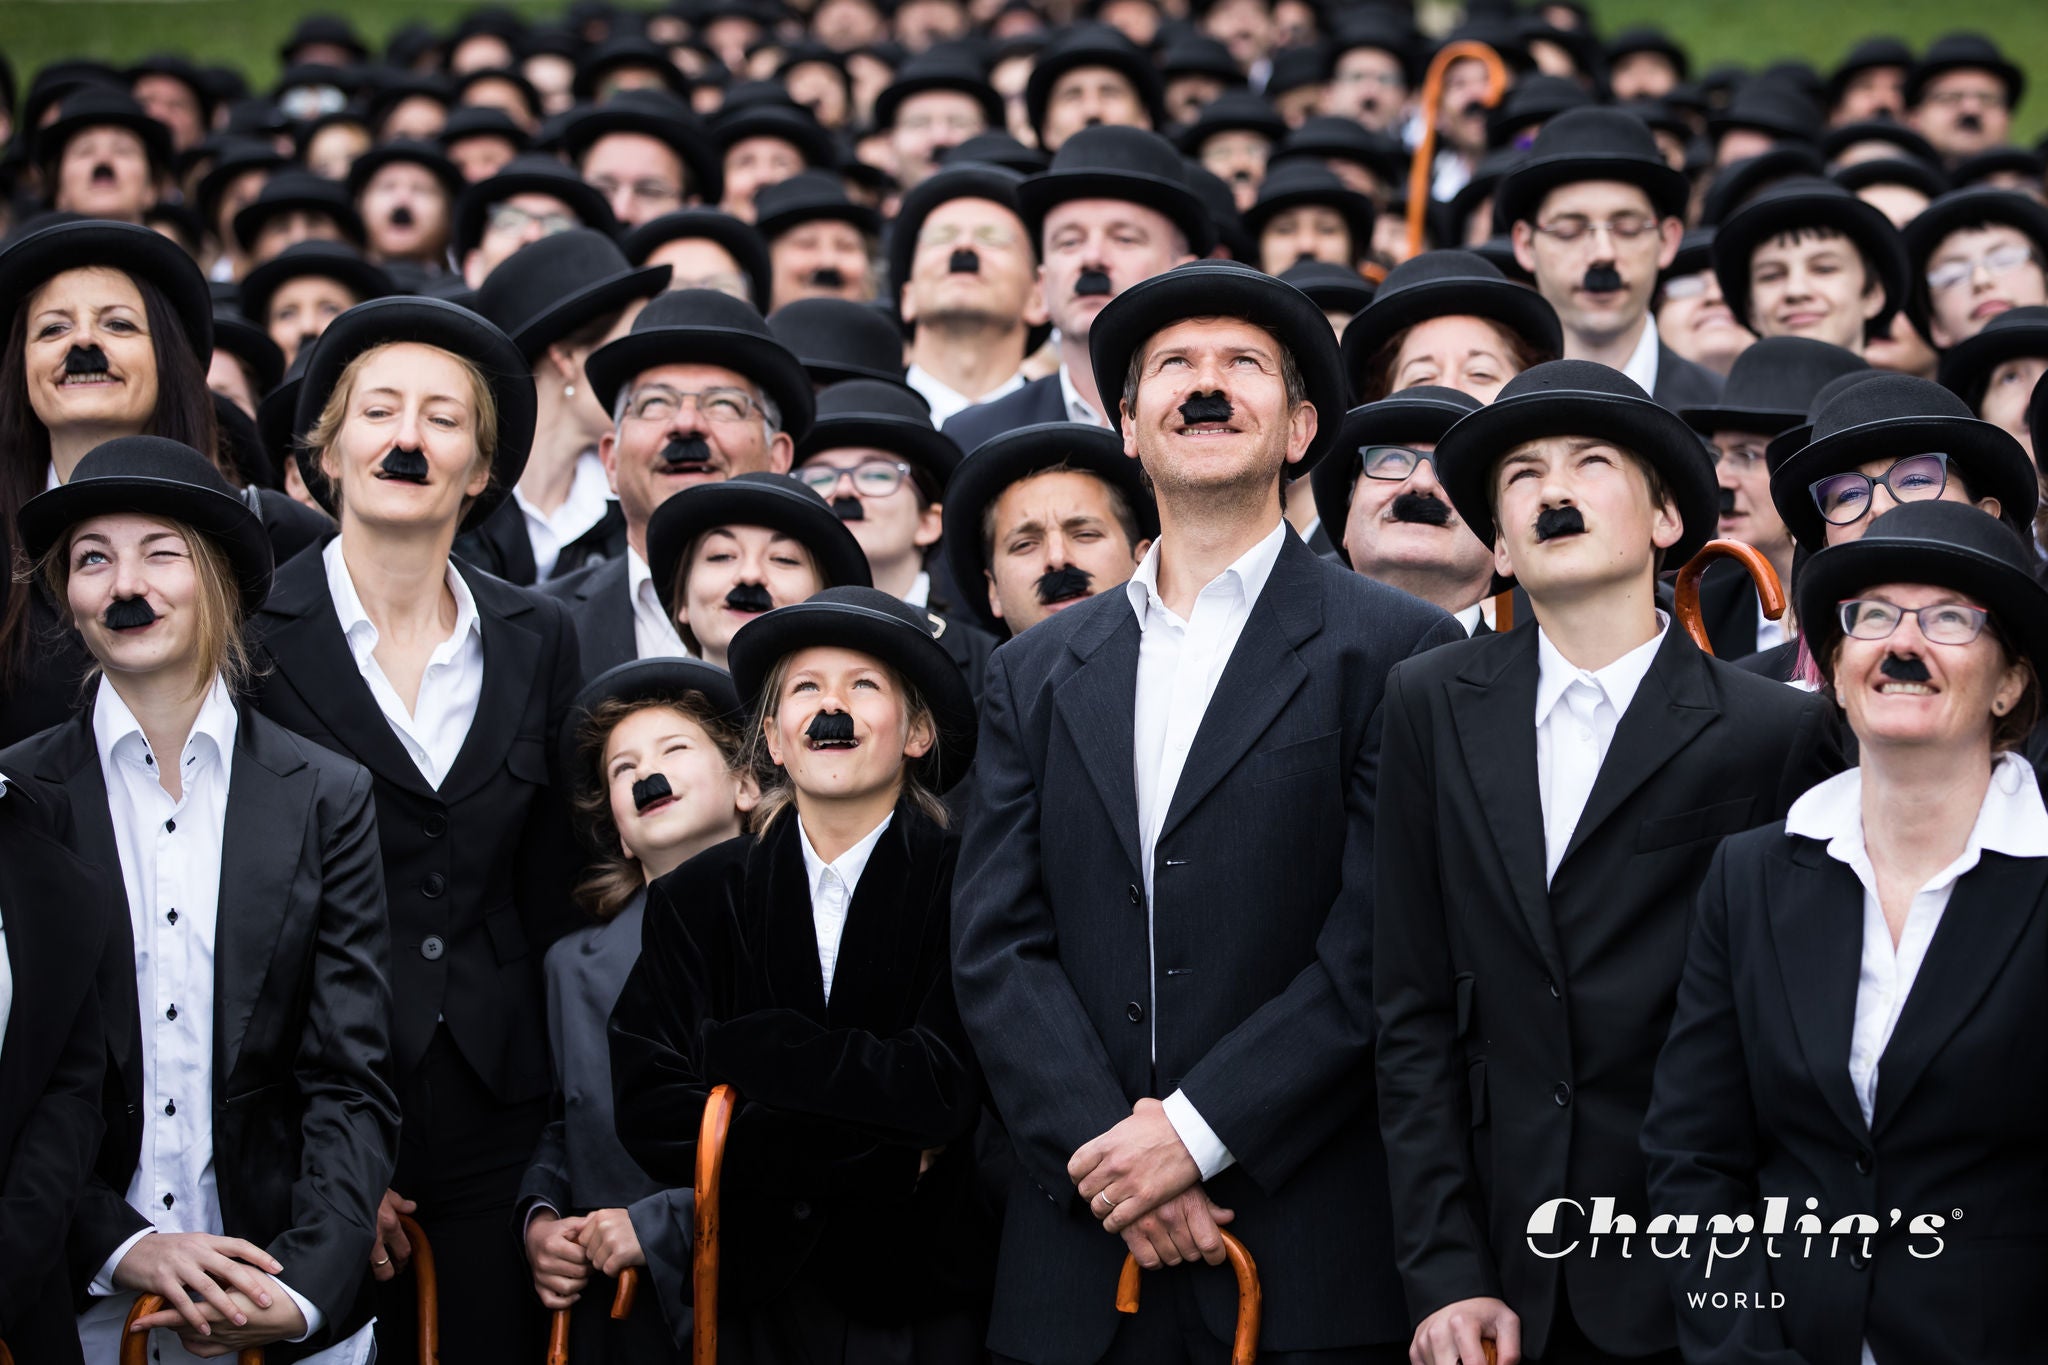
[647,473,872,620]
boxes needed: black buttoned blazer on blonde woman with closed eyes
[250,548,580,1103]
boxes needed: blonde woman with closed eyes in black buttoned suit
[254,299,578,1365]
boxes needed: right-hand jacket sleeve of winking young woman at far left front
[268,767,397,1326]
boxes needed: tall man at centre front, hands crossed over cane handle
[954,263,1460,1365]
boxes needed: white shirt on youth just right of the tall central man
[1536,612,1671,886]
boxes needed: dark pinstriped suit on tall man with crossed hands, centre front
[954,532,1464,1365]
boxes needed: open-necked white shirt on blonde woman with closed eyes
[322,536,483,790]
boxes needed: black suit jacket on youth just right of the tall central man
[1372,620,1837,1355]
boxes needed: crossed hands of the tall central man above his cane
[1067,1099,1235,1271]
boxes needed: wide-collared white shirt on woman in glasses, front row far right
[1786,753,2048,1365]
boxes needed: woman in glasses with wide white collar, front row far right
[1642,501,2048,1365]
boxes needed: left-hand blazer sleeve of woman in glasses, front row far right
[1642,839,1800,1365]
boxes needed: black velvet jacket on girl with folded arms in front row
[610,804,993,1324]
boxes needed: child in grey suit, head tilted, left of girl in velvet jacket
[518,659,760,1365]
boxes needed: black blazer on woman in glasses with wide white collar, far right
[1642,825,2048,1365]
